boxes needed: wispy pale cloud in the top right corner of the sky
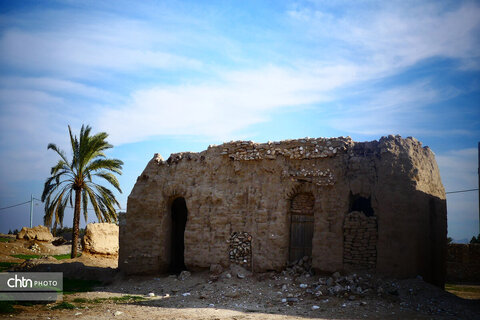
[289,2,480,75]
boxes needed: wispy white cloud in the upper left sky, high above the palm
[0,12,201,78]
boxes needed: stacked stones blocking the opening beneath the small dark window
[343,211,377,269]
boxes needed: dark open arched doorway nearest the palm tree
[170,198,188,273]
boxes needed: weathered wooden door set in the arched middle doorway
[288,193,315,262]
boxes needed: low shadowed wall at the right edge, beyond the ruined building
[447,243,480,282]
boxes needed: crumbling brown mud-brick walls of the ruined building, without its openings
[120,136,446,283]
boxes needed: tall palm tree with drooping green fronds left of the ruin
[42,125,123,258]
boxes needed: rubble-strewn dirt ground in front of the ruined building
[0,234,480,320]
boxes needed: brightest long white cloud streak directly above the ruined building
[98,66,362,144]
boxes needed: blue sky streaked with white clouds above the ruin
[0,0,480,239]
